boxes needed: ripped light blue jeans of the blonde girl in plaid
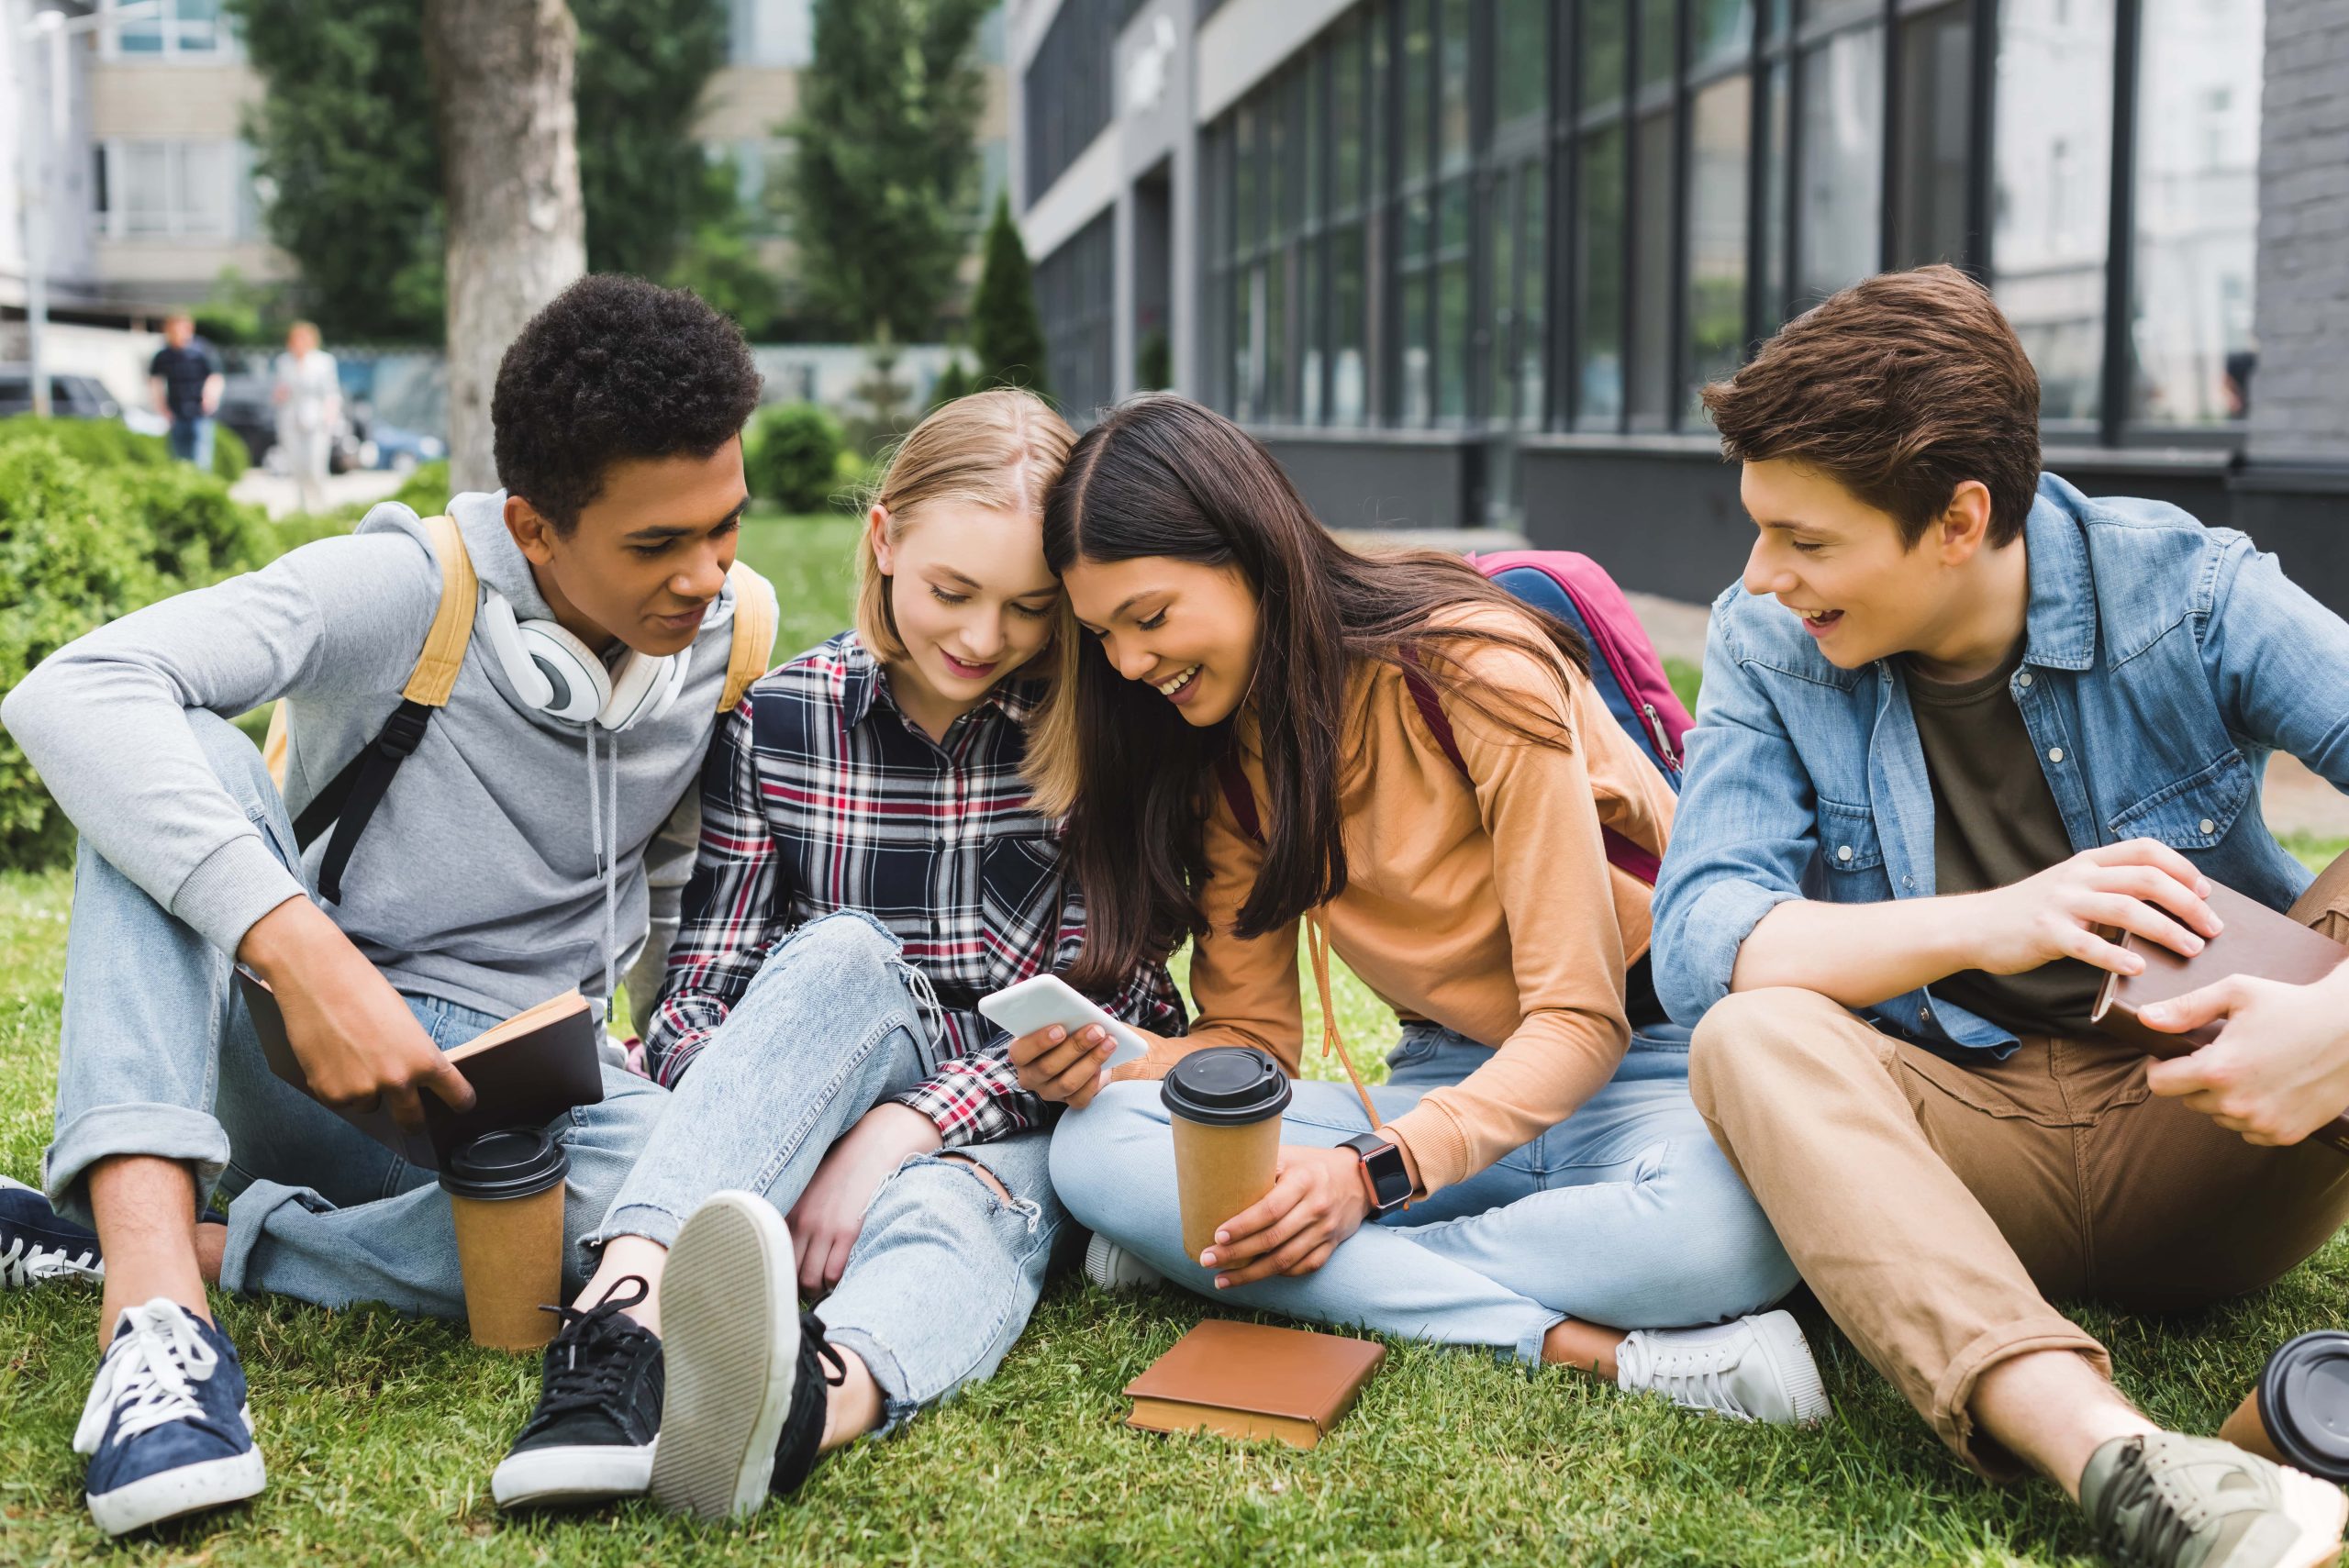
[590,911,1062,1432]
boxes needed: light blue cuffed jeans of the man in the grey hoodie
[42,714,667,1317]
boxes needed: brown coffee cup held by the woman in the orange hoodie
[1158,1044,1289,1262]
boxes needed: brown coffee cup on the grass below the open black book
[441,1129,571,1350]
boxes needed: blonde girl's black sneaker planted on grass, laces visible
[488,1274,664,1509]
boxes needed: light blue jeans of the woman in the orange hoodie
[1052,1023,1795,1362]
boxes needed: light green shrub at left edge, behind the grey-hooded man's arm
[0,439,165,869]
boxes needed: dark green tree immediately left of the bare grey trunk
[230,0,444,340]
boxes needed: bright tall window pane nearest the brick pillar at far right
[2128,0,2265,425]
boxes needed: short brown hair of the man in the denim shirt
[1703,265,2039,547]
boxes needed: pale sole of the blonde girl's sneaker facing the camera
[653,1193,798,1518]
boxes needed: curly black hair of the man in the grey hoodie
[488,272,759,533]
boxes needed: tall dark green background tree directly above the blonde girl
[785,0,994,343]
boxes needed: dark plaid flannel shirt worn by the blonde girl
[646,631,1186,1148]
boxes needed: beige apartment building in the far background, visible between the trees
[0,0,1010,321]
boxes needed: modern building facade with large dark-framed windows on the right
[1010,0,2349,608]
